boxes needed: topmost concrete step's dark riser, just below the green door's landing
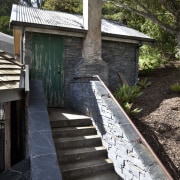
[50,118,92,128]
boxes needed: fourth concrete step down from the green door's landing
[57,146,107,164]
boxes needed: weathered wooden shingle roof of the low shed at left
[0,51,22,90]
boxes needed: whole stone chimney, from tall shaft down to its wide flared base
[76,0,108,84]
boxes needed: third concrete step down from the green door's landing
[54,135,102,150]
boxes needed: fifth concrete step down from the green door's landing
[60,157,114,180]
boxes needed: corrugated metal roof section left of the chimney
[10,5,82,29]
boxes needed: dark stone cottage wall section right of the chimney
[102,41,139,91]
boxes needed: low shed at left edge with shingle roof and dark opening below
[0,49,25,172]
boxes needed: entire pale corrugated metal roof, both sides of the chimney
[10,5,153,41]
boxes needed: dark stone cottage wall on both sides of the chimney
[64,37,139,106]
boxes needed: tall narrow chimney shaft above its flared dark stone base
[83,0,102,61]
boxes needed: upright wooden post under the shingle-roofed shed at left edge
[4,102,11,170]
